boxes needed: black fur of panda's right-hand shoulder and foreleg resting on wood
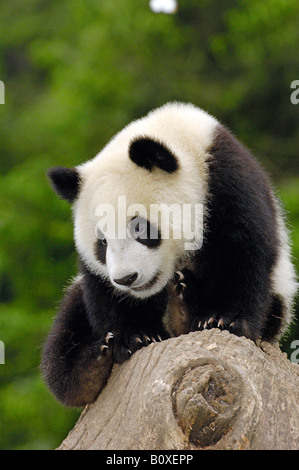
[172,125,283,340]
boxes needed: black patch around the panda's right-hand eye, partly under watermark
[129,216,161,248]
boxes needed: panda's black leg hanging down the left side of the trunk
[41,282,113,406]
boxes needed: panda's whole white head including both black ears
[48,104,213,298]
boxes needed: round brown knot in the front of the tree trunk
[172,364,243,447]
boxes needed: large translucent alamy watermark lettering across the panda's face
[95,196,203,250]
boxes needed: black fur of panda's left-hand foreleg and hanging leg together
[41,263,168,406]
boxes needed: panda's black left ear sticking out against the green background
[47,166,81,202]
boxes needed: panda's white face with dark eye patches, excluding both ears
[73,151,199,298]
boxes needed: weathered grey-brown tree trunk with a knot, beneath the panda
[59,329,299,450]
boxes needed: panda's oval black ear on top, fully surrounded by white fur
[129,137,179,173]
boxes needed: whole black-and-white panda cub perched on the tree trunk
[41,103,297,406]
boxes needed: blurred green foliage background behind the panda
[0,0,299,449]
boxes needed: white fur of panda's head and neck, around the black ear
[73,103,218,297]
